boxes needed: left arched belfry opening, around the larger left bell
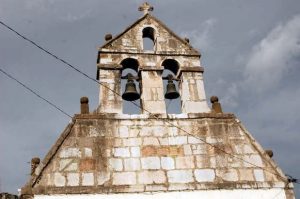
[121,58,141,114]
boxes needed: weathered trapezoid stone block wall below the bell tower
[34,114,285,193]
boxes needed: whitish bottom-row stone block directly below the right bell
[167,170,194,183]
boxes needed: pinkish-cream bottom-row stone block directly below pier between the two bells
[138,171,166,184]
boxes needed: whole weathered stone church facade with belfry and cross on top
[22,3,295,199]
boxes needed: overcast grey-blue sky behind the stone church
[0,0,300,195]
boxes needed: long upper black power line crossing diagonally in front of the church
[0,18,298,185]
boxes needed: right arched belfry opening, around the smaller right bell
[162,59,181,114]
